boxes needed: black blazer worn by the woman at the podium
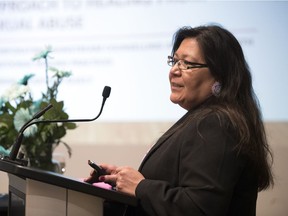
[126,111,257,216]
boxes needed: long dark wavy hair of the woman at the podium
[171,25,273,191]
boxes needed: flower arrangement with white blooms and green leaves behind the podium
[0,47,76,170]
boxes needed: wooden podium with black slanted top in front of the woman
[0,160,137,216]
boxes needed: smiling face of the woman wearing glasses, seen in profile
[169,38,215,110]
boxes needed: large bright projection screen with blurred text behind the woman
[0,0,288,122]
